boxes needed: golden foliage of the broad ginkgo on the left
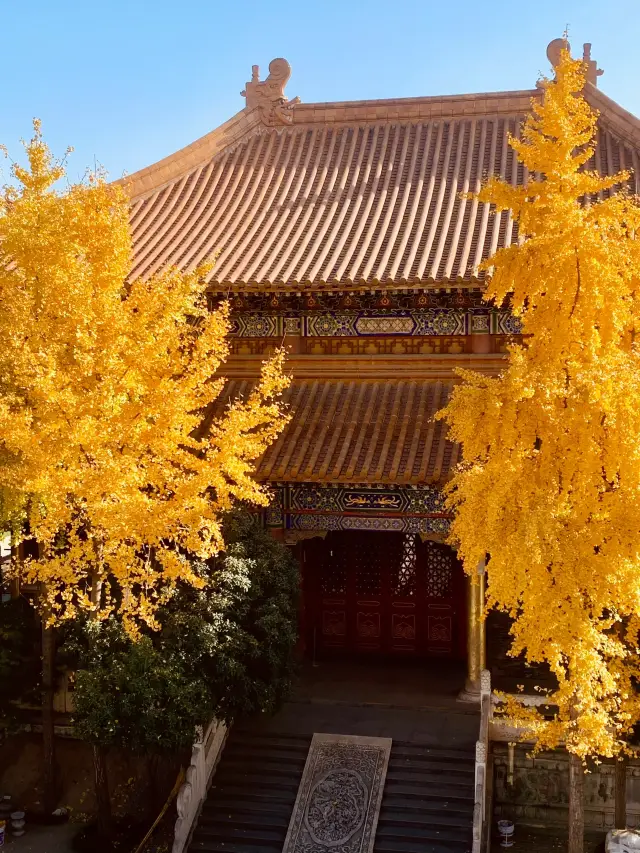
[0,122,288,625]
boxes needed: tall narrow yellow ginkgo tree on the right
[441,48,640,851]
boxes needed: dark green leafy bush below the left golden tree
[65,513,299,754]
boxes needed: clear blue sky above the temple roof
[0,0,640,179]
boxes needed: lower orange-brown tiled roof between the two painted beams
[216,379,460,485]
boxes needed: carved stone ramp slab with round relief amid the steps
[282,734,391,853]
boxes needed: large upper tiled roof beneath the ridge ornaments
[120,84,640,292]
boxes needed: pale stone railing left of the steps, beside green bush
[171,720,227,853]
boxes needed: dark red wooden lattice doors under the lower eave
[304,531,464,657]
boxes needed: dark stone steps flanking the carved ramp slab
[189,731,474,853]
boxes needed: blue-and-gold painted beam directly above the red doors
[265,483,450,533]
